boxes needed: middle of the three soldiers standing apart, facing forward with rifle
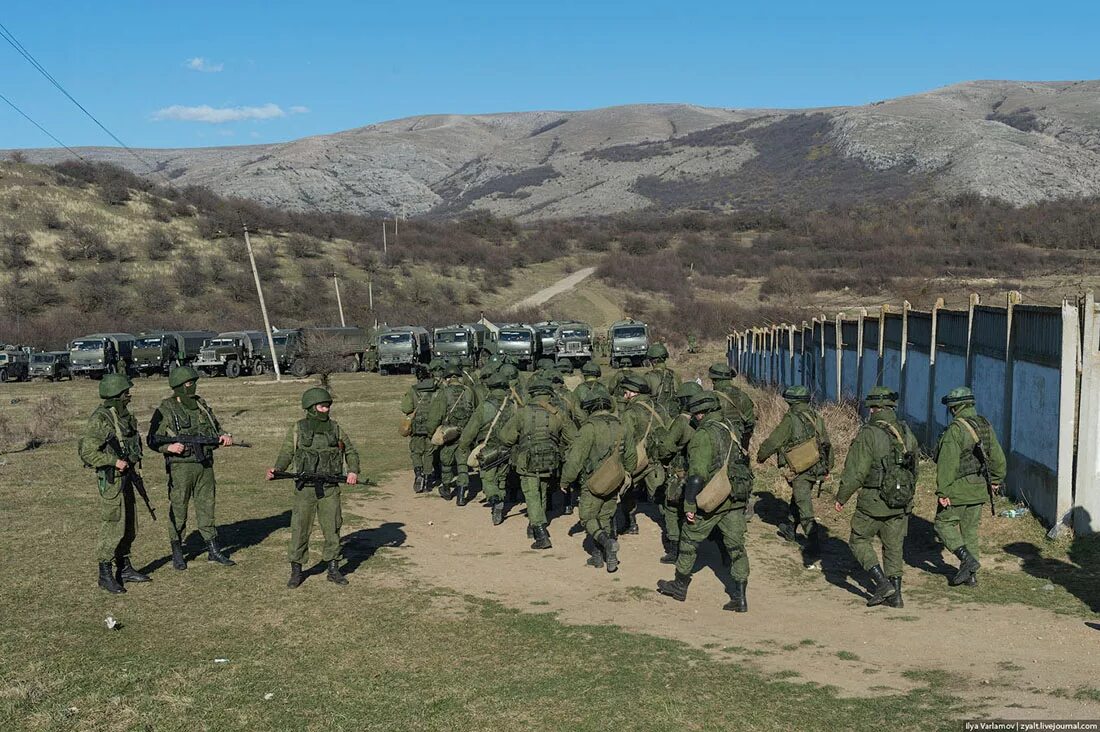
[146,367,237,569]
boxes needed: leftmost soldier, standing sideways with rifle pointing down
[77,373,150,594]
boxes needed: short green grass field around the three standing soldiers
[0,374,1096,731]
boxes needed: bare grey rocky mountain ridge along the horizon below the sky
[12,81,1100,220]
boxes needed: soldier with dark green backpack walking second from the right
[834,386,920,608]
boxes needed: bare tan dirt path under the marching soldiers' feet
[348,473,1100,719]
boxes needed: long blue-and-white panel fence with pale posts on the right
[728,293,1100,534]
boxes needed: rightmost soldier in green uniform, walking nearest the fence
[935,386,1008,587]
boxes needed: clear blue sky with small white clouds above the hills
[0,0,1100,148]
